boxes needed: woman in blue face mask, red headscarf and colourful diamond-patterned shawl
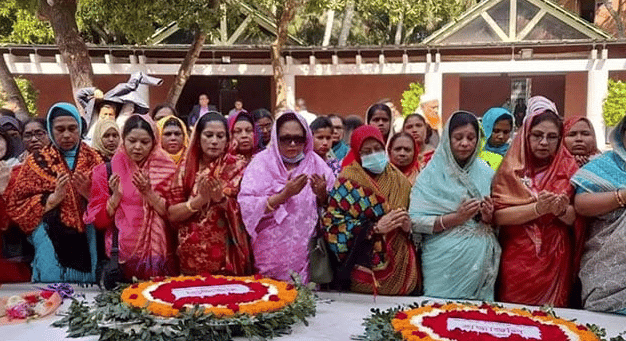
[323,125,421,295]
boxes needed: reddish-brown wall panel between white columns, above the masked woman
[296,75,424,117]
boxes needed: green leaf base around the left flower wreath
[52,282,316,341]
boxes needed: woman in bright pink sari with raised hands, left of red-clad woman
[85,115,177,279]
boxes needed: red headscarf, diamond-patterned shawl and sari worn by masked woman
[323,125,421,295]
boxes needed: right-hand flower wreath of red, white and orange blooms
[355,302,623,341]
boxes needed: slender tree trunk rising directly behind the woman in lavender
[271,0,298,107]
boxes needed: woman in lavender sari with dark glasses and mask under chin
[238,111,335,283]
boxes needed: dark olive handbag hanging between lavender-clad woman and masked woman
[309,214,334,284]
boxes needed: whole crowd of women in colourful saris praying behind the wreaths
[0,96,626,313]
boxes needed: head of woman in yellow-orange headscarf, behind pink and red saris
[157,116,189,165]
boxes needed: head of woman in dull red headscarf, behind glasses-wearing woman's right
[563,116,600,167]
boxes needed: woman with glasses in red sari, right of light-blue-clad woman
[492,109,582,307]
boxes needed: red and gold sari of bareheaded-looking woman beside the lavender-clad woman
[169,113,253,276]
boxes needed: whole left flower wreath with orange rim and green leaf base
[53,275,316,341]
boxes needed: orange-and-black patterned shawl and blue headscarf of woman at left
[5,103,102,272]
